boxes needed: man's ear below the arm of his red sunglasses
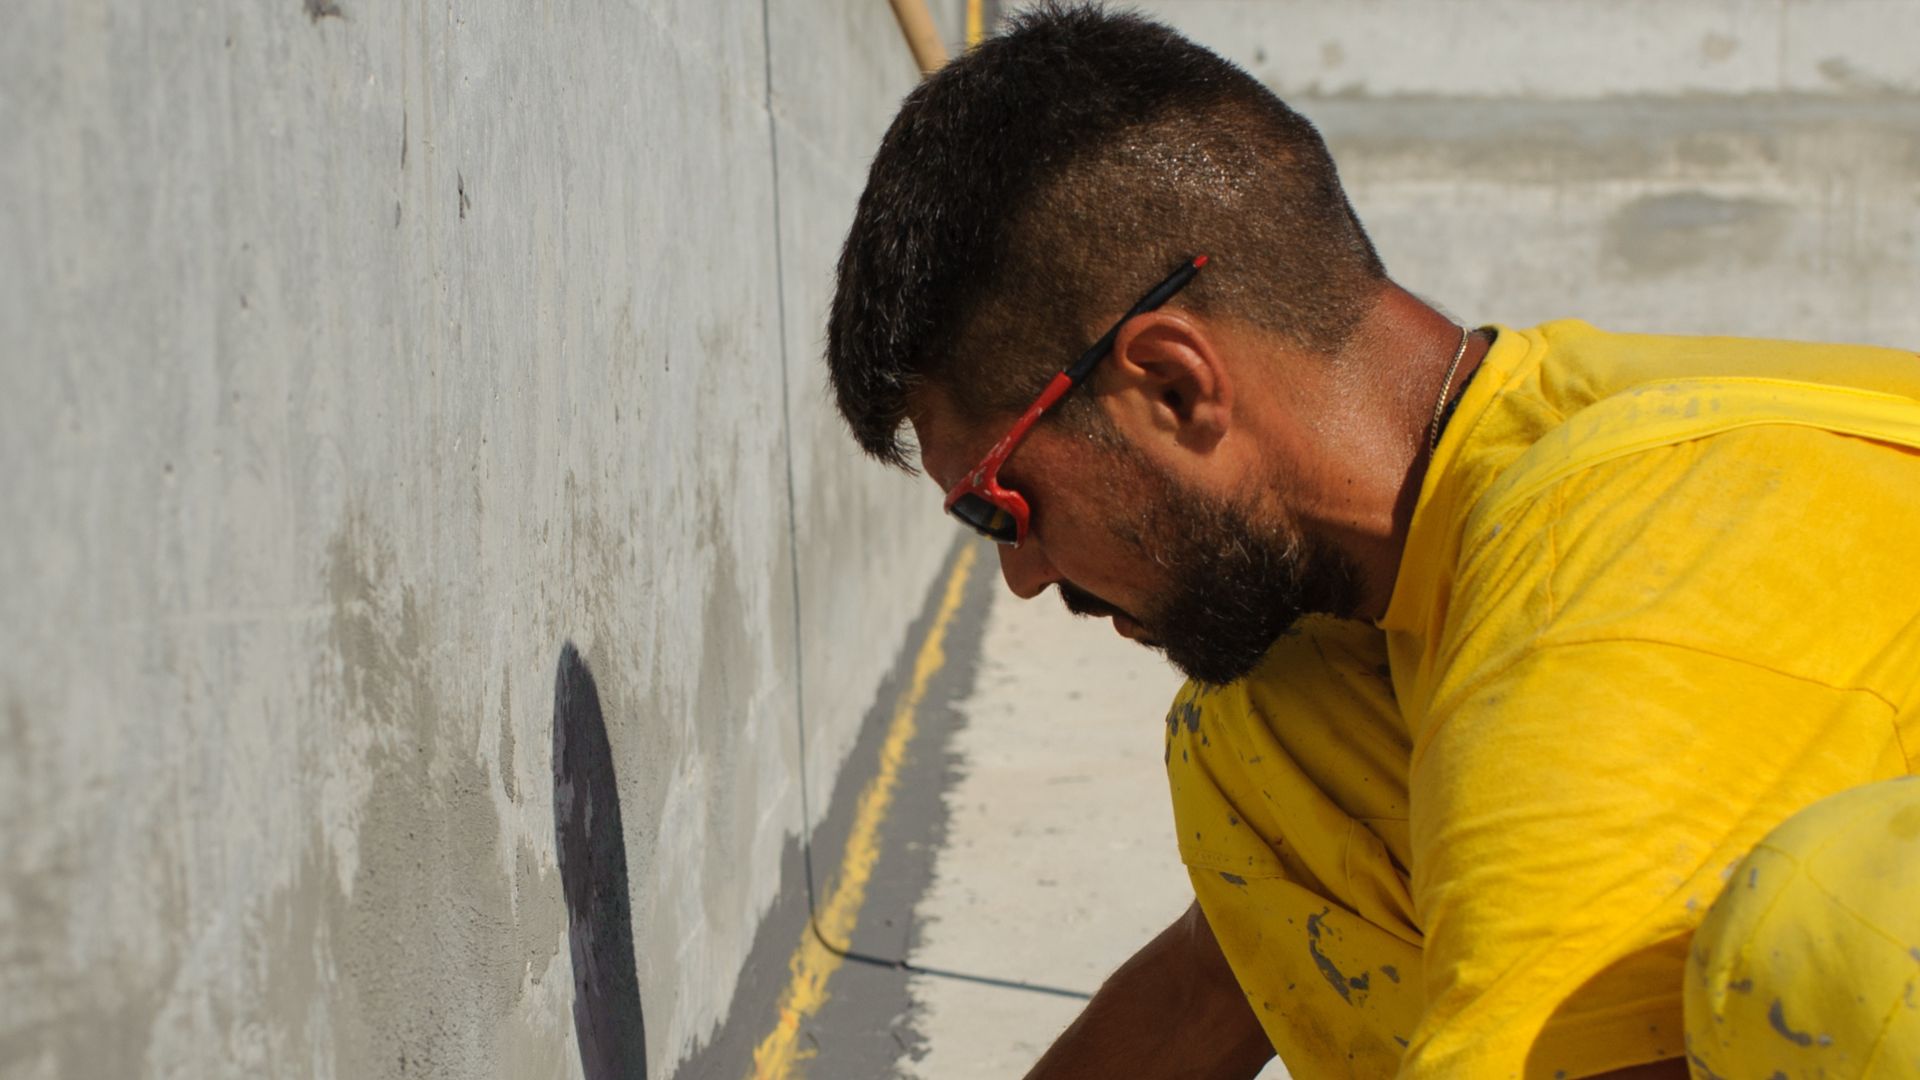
[1092,311,1233,454]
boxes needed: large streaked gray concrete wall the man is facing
[0,0,958,1080]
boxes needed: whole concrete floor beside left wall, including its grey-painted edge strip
[756,548,1286,1080]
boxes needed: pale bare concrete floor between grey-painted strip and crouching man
[899,565,1286,1080]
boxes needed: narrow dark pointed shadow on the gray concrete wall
[553,642,647,1080]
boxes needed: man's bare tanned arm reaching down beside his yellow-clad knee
[1027,903,1273,1080]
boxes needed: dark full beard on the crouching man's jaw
[1114,459,1359,686]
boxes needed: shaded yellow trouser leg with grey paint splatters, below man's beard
[1167,619,1421,1076]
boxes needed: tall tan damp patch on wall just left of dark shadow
[318,515,564,1078]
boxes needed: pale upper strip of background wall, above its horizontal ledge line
[1137,0,1920,100]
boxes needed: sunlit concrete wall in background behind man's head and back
[1140,0,1920,348]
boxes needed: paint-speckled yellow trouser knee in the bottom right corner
[1686,778,1920,1080]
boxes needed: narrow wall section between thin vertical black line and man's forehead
[768,0,966,821]
